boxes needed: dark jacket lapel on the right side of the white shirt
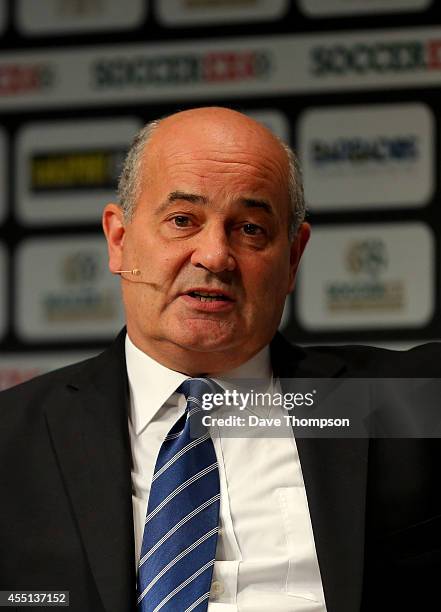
[271,335,368,612]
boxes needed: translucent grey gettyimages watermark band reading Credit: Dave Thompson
[191,378,441,438]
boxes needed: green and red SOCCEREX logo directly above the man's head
[91,50,271,89]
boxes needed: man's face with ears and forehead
[104,110,305,374]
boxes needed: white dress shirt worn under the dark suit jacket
[126,336,326,612]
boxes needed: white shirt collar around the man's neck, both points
[125,334,272,435]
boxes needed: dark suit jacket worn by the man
[0,331,441,612]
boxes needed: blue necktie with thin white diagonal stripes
[137,378,220,612]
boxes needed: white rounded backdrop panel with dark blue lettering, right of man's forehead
[298,104,434,210]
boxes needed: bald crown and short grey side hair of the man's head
[118,107,305,237]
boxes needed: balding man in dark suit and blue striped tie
[0,108,441,612]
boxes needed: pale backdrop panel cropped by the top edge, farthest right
[298,0,432,17]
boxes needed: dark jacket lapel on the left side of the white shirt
[46,331,136,612]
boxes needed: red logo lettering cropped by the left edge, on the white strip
[0,62,55,96]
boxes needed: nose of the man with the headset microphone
[191,223,236,273]
